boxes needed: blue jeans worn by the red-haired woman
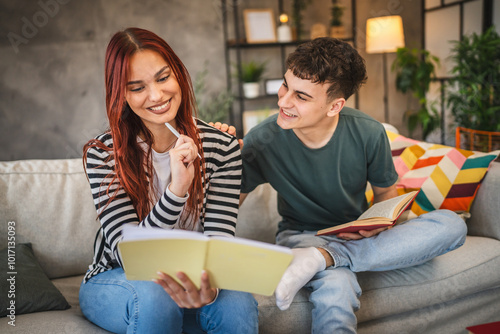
[80,268,258,334]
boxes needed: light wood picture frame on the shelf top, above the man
[243,8,277,43]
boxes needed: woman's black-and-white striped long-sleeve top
[85,120,242,282]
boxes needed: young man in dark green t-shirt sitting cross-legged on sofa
[236,38,466,333]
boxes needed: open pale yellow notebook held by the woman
[118,226,293,296]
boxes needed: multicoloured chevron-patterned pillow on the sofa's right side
[394,142,500,216]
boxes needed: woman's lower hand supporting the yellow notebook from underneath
[153,271,217,308]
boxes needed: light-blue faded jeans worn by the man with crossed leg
[276,210,467,334]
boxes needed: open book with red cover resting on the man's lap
[316,191,418,235]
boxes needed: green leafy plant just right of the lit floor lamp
[392,47,440,139]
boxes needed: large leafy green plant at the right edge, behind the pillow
[447,27,500,131]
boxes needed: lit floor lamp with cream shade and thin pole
[366,15,405,123]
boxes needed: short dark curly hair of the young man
[286,37,367,101]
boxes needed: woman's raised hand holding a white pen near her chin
[169,135,198,197]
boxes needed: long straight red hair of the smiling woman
[83,28,205,227]
